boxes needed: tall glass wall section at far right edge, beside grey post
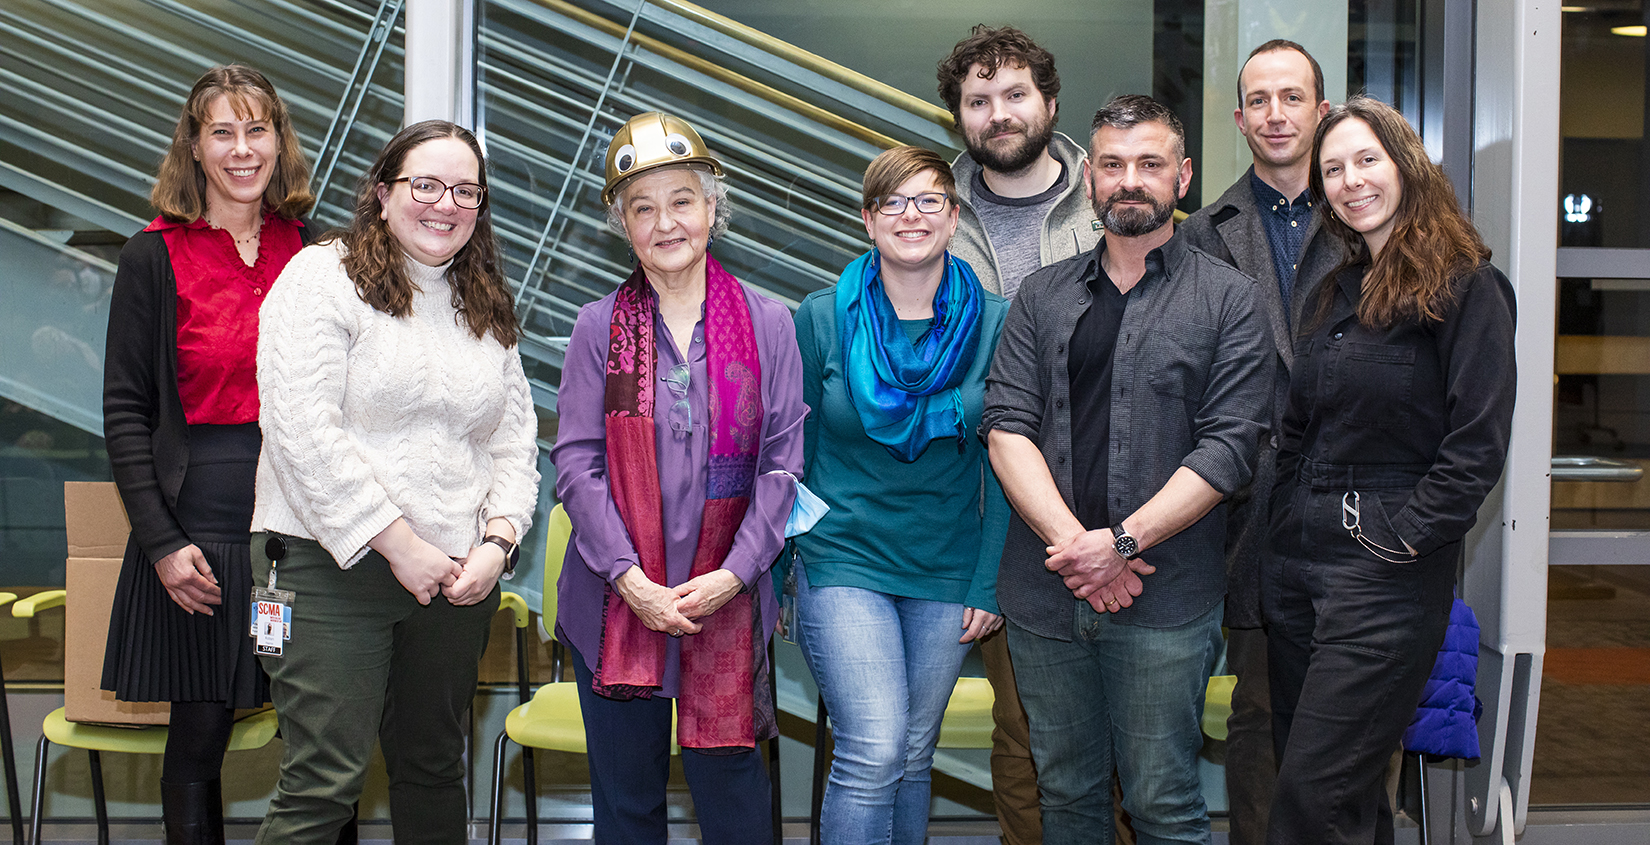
[1530,0,1650,804]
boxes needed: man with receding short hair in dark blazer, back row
[1180,40,1343,845]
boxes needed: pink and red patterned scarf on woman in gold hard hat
[594,256,772,749]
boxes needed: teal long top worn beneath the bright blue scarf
[797,287,1008,614]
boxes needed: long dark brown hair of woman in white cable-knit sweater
[322,120,521,348]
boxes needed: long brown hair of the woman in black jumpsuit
[1310,97,1490,328]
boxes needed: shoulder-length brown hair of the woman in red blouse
[149,64,315,223]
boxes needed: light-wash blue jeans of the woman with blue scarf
[797,566,969,845]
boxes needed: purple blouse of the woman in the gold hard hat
[549,284,807,698]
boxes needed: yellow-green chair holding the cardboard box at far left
[13,589,277,845]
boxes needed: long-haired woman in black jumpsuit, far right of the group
[1262,97,1515,845]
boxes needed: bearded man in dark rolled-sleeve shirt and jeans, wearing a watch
[980,96,1275,845]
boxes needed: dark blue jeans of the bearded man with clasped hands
[1008,602,1223,845]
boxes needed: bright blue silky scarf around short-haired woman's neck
[837,249,983,464]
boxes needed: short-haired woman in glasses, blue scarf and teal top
[797,147,1008,845]
